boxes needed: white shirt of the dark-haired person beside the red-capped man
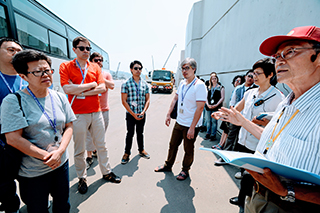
[238,86,285,151]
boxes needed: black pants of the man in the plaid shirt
[125,113,146,155]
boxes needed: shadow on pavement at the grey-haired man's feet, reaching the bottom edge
[157,172,196,213]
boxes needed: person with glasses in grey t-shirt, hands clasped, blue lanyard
[1,50,76,213]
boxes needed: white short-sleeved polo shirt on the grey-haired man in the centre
[176,78,207,127]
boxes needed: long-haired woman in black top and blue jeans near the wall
[205,72,224,141]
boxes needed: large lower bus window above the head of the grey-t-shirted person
[15,13,49,52]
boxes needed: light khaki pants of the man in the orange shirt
[73,112,111,178]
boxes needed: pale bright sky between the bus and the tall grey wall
[38,0,198,75]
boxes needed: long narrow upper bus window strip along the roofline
[11,0,67,36]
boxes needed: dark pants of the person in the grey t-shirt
[18,161,70,213]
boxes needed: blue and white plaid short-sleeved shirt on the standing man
[121,77,149,114]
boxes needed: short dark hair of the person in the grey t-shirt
[12,50,52,75]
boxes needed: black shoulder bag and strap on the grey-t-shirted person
[0,93,25,180]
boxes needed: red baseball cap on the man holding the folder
[260,26,320,56]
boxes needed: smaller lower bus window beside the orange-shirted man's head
[49,31,68,57]
